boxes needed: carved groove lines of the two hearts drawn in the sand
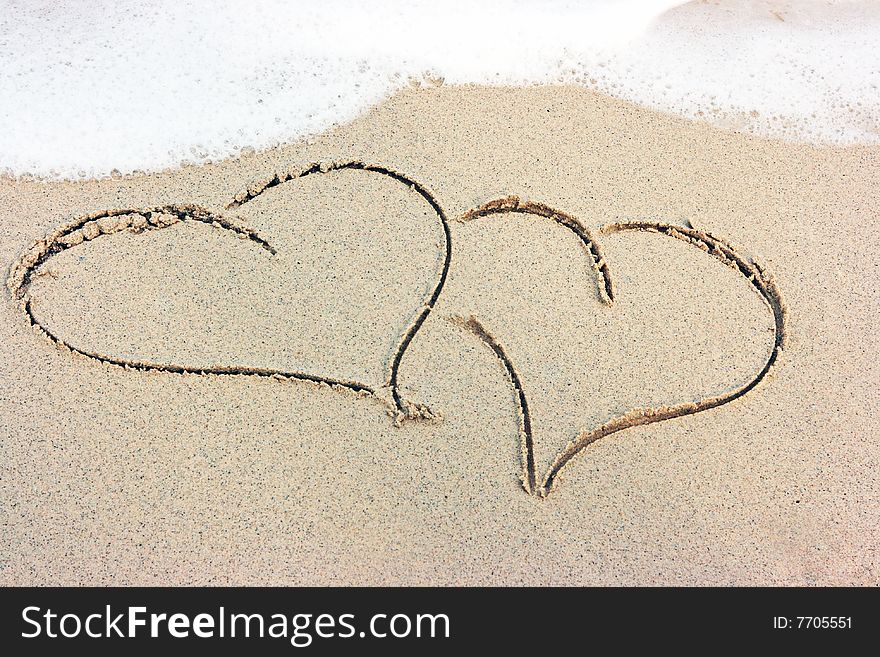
[7,162,786,497]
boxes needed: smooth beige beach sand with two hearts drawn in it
[0,86,880,585]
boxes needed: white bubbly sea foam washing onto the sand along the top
[0,0,880,177]
